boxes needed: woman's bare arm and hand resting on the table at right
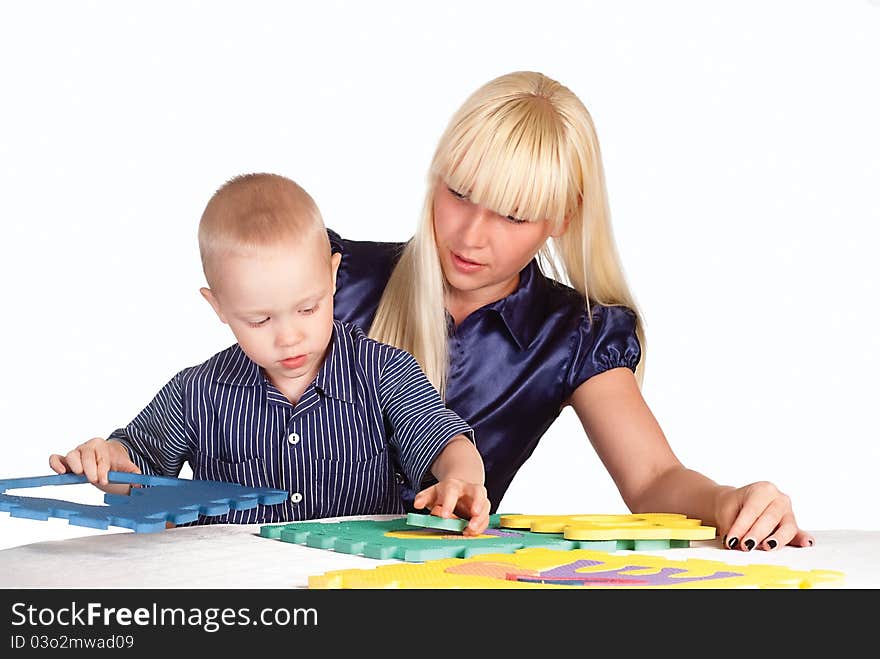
[569,368,813,551]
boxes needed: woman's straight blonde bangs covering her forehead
[432,95,580,226]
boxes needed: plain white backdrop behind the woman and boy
[0,0,880,546]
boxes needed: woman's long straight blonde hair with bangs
[370,71,645,395]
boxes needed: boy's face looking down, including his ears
[202,245,341,392]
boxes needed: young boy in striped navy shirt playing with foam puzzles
[49,174,490,535]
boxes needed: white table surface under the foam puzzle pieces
[0,515,880,588]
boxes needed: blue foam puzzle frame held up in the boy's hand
[0,471,288,533]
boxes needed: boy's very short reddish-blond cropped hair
[199,173,330,286]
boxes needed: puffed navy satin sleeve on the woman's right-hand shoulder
[564,303,642,399]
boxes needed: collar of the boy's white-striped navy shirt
[214,320,354,403]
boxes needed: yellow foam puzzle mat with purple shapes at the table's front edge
[308,548,845,589]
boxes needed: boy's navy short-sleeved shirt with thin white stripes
[108,320,473,524]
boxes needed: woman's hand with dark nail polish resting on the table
[715,481,815,551]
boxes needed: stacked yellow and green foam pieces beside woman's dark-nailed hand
[500,513,715,551]
